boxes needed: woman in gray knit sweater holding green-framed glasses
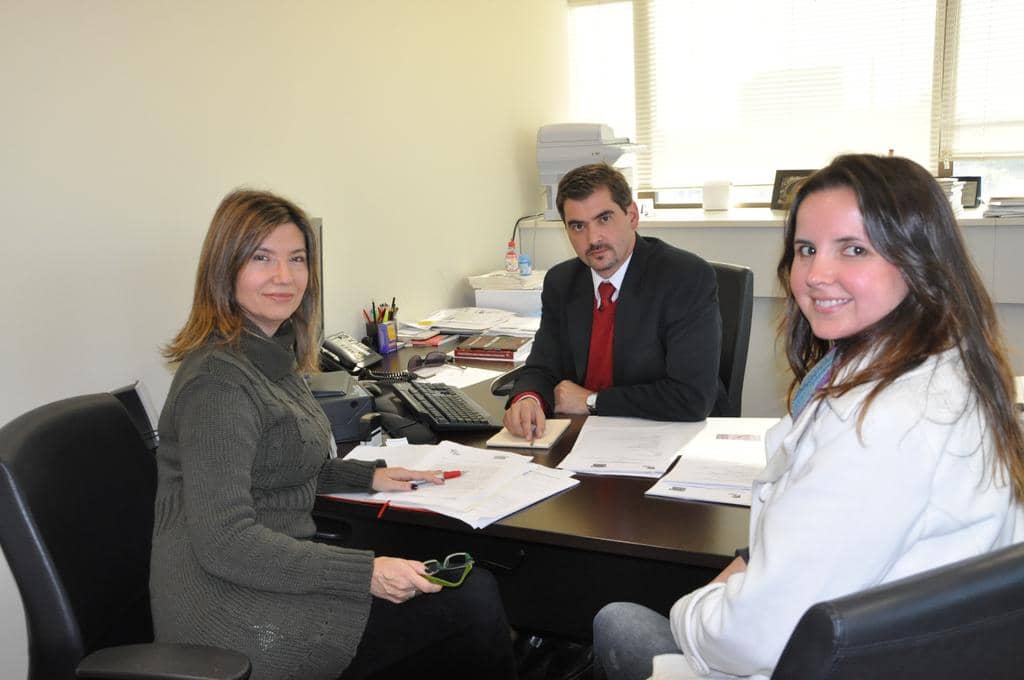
[151,190,515,680]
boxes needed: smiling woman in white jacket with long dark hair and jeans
[594,155,1024,680]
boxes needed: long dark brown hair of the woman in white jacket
[777,155,1024,500]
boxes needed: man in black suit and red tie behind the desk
[505,164,725,439]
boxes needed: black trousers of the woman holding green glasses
[339,568,516,680]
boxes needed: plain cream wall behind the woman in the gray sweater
[0,0,566,678]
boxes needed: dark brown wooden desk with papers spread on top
[313,352,750,639]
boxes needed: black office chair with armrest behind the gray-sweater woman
[0,393,251,680]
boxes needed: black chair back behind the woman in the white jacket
[772,544,1024,680]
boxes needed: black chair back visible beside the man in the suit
[711,262,754,417]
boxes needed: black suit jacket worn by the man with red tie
[510,236,725,421]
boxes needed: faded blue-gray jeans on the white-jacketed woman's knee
[594,602,682,680]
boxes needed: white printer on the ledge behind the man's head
[537,123,640,221]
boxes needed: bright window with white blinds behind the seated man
[568,0,1024,203]
